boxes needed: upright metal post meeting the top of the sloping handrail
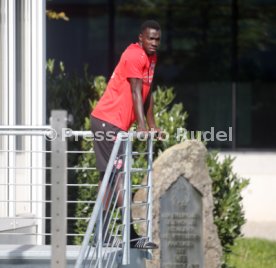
[122,136,132,265]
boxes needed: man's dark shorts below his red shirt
[91,116,124,172]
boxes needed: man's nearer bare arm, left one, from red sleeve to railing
[129,78,147,131]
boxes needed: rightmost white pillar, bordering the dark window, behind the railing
[31,0,46,244]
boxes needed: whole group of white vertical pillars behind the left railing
[0,0,46,243]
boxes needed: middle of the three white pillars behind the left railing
[16,0,34,220]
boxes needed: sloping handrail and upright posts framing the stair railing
[75,132,154,268]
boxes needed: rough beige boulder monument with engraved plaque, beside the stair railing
[133,140,222,268]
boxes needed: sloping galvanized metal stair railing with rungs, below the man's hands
[75,129,153,268]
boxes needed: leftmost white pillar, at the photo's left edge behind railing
[0,0,16,216]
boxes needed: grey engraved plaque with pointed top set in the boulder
[160,176,203,268]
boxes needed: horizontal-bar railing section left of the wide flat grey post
[0,126,51,244]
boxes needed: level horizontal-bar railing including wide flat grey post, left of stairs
[0,111,98,268]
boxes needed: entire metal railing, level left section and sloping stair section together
[0,111,152,268]
